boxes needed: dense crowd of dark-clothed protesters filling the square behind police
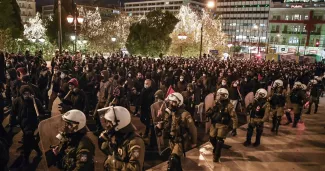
[0,50,325,170]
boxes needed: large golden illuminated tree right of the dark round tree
[169,6,227,57]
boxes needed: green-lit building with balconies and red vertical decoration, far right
[269,0,325,57]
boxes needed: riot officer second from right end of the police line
[290,81,306,128]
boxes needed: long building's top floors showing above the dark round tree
[124,0,205,16]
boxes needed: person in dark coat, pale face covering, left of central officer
[140,79,155,138]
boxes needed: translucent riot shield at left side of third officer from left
[150,102,169,156]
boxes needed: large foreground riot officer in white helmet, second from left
[98,106,145,171]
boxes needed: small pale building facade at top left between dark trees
[17,0,36,23]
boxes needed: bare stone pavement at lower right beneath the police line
[148,98,325,171]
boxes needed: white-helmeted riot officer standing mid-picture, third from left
[158,93,197,171]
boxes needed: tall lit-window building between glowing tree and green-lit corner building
[216,0,270,53]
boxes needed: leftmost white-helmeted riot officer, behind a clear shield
[52,110,95,171]
